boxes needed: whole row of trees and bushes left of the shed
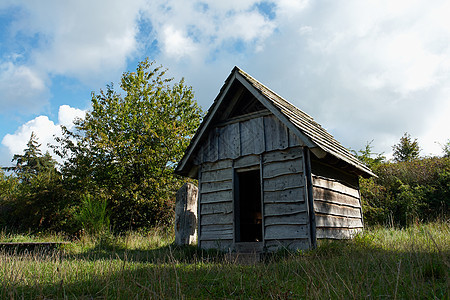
[0,60,203,234]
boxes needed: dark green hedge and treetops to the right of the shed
[355,133,450,226]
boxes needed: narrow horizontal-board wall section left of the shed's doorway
[199,160,234,251]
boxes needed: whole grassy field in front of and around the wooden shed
[0,222,450,299]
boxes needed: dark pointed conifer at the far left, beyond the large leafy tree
[3,133,70,230]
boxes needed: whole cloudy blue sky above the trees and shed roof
[0,0,450,166]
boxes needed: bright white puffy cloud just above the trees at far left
[2,105,85,157]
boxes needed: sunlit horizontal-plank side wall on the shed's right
[312,175,363,239]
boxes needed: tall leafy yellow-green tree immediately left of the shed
[56,60,203,230]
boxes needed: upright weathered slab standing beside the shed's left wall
[175,183,198,245]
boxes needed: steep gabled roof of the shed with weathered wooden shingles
[175,67,376,177]
